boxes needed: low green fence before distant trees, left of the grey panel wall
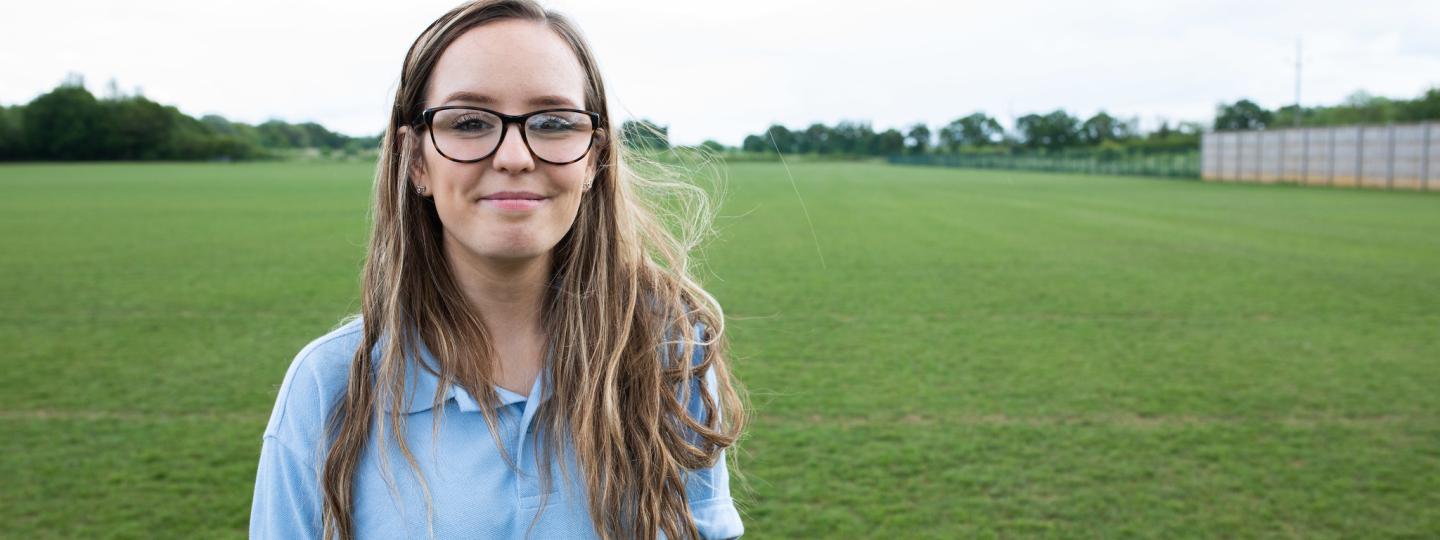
[888,151,1200,179]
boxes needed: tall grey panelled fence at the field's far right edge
[1200,122,1440,190]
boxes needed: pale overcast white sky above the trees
[0,0,1440,144]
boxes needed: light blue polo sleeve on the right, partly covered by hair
[685,323,744,539]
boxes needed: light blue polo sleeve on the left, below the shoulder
[251,435,321,539]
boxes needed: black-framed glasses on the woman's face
[420,105,600,166]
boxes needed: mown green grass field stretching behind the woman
[0,163,1440,539]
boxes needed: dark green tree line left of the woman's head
[0,75,380,161]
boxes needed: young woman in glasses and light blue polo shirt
[251,0,744,539]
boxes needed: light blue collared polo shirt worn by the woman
[251,318,744,539]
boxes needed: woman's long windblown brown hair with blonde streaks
[321,0,746,540]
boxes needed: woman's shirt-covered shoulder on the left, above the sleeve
[265,318,364,448]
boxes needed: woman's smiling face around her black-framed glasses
[402,19,598,266]
